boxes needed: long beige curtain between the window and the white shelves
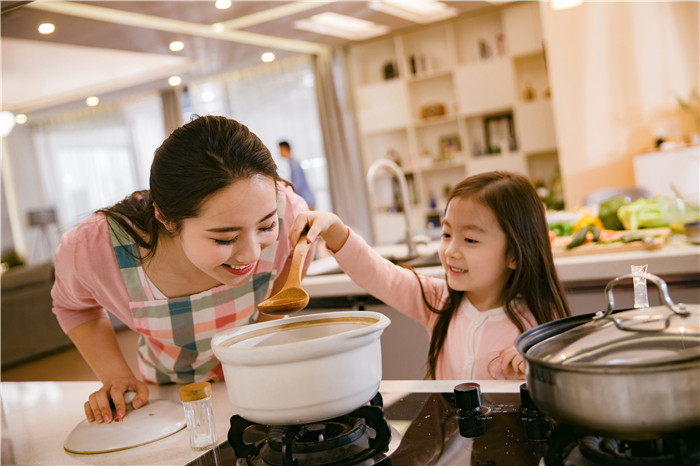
[314,49,373,244]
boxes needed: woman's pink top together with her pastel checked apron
[51,184,313,383]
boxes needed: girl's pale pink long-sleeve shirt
[333,230,536,380]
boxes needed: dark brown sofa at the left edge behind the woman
[0,261,73,369]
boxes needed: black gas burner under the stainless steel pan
[544,427,700,466]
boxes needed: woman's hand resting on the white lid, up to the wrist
[84,378,148,424]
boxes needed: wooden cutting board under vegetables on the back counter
[552,228,671,257]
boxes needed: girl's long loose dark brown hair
[421,171,571,379]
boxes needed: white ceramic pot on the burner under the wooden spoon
[212,311,390,425]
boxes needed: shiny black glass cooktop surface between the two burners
[189,386,543,466]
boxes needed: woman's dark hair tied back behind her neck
[98,116,279,256]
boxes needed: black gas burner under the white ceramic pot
[228,397,398,466]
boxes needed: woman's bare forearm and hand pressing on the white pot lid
[68,318,148,424]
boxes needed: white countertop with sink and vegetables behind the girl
[302,235,700,300]
